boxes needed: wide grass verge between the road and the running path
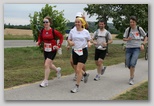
[4,44,144,88]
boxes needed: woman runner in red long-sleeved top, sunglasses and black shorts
[37,16,63,87]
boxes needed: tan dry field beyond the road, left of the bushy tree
[4,28,33,36]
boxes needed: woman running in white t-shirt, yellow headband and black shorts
[68,18,91,93]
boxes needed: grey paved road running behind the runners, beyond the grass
[4,40,123,48]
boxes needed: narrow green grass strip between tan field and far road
[4,34,34,40]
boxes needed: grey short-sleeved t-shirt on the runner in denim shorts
[123,26,146,48]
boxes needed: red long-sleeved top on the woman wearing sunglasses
[38,29,63,51]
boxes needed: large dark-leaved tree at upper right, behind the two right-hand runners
[84,4,148,33]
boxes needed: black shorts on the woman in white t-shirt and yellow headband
[72,48,88,65]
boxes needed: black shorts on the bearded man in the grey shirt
[95,49,106,60]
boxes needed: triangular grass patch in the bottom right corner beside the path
[114,82,148,100]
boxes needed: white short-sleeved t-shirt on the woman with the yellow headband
[68,27,91,49]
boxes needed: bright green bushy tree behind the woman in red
[29,4,68,41]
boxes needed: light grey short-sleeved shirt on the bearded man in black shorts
[93,29,112,50]
